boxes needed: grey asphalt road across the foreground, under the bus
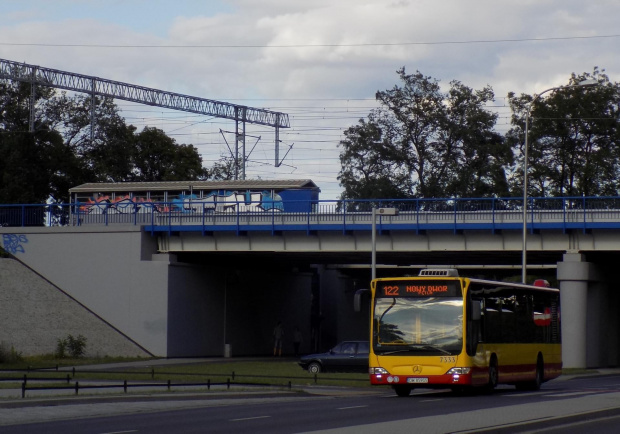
[0,374,620,434]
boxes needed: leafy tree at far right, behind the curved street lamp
[507,68,620,196]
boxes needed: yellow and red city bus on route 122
[355,269,562,397]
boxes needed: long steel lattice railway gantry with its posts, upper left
[0,59,290,179]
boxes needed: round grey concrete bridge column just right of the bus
[558,252,594,368]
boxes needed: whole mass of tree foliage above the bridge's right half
[338,68,620,199]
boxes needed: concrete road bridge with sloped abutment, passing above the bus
[0,198,620,367]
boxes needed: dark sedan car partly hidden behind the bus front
[299,341,370,374]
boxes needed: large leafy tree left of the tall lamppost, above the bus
[338,68,512,198]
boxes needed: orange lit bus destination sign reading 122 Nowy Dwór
[377,280,461,297]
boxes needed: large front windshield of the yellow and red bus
[373,297,463,356]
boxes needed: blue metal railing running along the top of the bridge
[0,197,620,234]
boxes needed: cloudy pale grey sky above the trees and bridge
[0,0,620,199]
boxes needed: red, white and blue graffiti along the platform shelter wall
[79,191,284,214]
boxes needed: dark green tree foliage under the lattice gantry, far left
[0,80,213,203]
